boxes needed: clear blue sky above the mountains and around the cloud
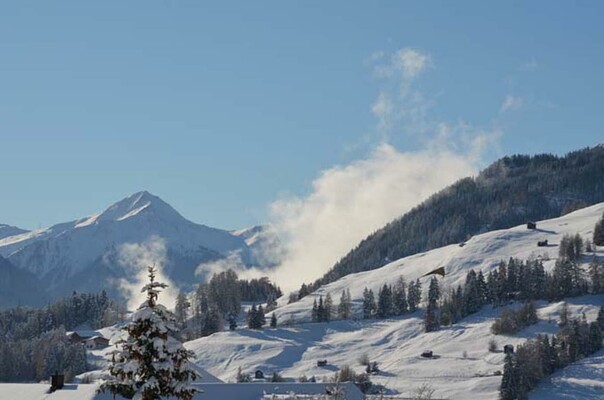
[0,1,604,229]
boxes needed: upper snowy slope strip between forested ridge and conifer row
[279,203,604,321]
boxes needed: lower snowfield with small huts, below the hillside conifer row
[186,296,604,399]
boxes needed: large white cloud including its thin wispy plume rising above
[258,48,502,290]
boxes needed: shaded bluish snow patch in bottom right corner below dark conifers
[529,350,604,400]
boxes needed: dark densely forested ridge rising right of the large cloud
[311,145,604,289]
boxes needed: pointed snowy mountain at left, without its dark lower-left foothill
[0,191,254,300]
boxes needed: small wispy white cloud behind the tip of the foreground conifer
[118,236,178,310]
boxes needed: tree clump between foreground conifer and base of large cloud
[175,270,282,340]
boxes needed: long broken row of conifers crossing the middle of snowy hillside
[300,250,604,332]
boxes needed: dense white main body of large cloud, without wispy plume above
[271,144,476,289]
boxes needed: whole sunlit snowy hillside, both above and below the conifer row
[186,204,604,399]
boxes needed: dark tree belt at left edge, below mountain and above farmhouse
[0,291,126,340]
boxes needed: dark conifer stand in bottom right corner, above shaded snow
[500,309,604,400]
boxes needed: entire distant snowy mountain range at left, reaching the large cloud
[0,191,276,307]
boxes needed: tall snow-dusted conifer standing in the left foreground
[100,267,197,400]
